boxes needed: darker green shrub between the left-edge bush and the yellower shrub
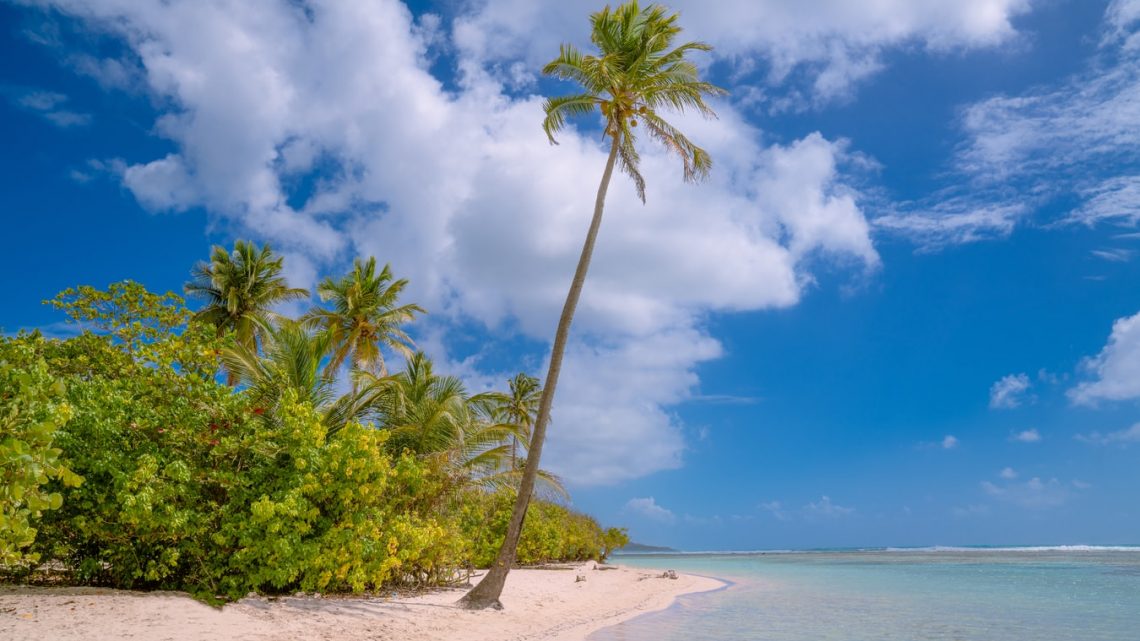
[19,326,240,589]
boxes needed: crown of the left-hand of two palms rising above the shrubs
[185,241,309,384]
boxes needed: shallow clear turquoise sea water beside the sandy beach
[589,549,1140,641]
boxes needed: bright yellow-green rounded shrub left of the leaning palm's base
[210,394,461,594]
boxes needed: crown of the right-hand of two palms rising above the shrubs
[303,258,424,376]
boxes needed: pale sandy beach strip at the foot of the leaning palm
[0,563,722,641]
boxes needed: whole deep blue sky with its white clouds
[0,0,1140,550]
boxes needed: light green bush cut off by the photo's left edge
[0,349,82,565]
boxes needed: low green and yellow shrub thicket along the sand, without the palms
[0,283,612,600]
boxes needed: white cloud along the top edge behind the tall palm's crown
[456,0,1032,106]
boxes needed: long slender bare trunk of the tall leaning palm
[459,133,620,610]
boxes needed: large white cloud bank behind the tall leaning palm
[28,0,880,485]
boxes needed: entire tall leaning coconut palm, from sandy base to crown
[459,0,724,609]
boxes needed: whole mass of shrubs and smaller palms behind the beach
[0,241,624,601]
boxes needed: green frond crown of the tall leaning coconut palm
[543,0,725,202]
